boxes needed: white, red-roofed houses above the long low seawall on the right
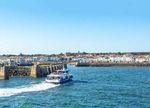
[72,54,150,63]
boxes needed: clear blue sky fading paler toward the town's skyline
[0,0,150,54]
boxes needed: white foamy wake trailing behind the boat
[0,82,59,97]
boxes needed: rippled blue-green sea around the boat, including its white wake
[0,66,150,108]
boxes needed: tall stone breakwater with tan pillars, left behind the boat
[0,63,67,80]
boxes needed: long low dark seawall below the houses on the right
[75,62,150,67]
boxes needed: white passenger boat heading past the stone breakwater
[45,69,73,84]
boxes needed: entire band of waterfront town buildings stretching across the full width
[0,53,150,65]
